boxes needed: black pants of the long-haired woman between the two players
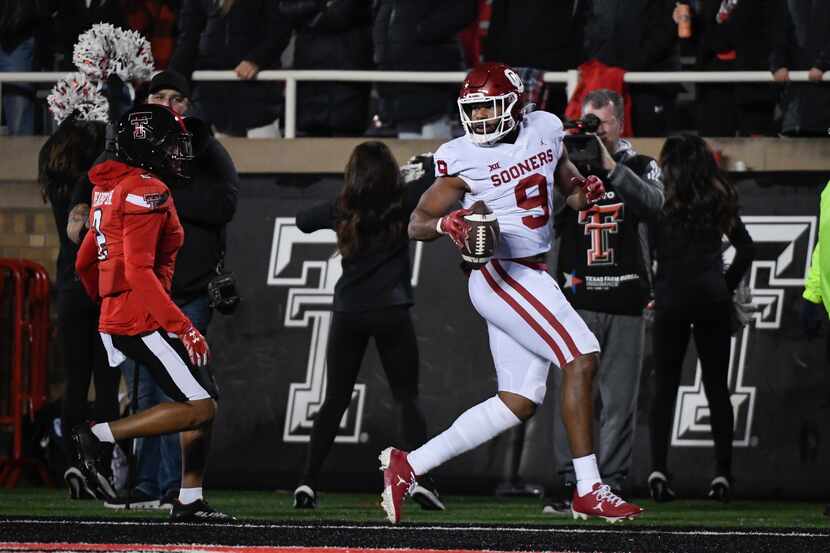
[302,306,427,488]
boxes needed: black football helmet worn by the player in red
[115,104,193,178]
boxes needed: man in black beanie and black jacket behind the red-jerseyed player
[100,71,239,509]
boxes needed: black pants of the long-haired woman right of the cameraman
[650,301,734,478]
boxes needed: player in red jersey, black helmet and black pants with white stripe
[72,105,231,522]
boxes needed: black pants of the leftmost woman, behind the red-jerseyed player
[58,288,121,454]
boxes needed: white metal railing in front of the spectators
[0,69,830,138]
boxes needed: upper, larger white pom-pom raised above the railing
[72,23,155,81]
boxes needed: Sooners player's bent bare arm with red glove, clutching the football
[409,177,469,244]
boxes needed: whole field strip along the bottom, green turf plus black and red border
[0,488,830,553]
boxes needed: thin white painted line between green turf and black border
[0,519,830,539]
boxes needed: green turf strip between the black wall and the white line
[0,488,830,528]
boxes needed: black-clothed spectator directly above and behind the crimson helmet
[484,0,585,113]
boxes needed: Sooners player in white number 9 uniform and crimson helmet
[380,63,642,522]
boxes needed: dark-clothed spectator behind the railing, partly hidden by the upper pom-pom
[52,0,127,71]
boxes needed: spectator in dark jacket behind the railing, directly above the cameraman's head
[585,0,678,136]
